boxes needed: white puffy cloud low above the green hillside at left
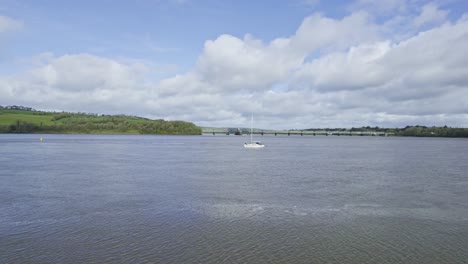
[0,54,146,112]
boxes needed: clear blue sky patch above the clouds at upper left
[3,0,324,70]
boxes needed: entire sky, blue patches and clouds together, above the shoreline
[0,0,468,129]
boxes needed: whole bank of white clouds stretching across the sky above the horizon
[0,1,468,129]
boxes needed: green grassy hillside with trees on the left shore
[0,107,201,135]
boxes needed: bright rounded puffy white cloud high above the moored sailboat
[195,35,301,92]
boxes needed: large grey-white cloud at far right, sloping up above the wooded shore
[288,16,468,124]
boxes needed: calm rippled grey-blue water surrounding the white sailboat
[0,135,468,263]
